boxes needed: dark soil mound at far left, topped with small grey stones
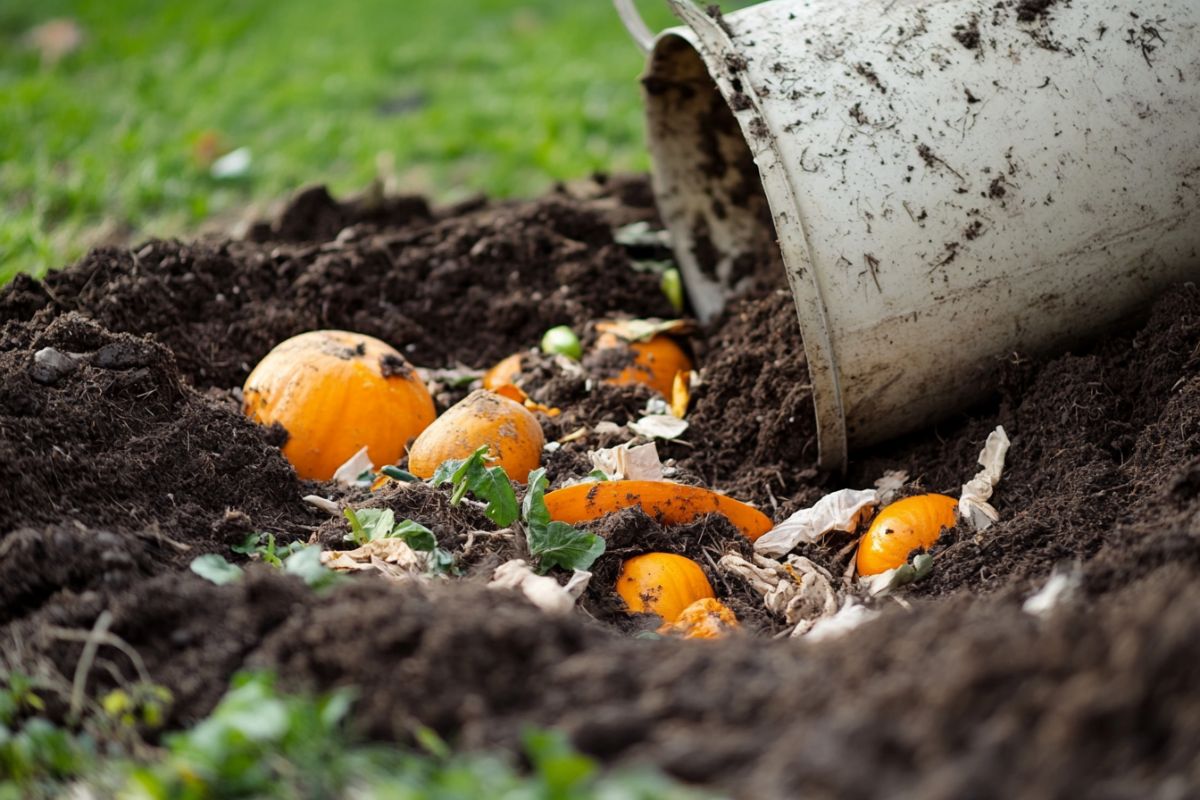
[0,313,312,551]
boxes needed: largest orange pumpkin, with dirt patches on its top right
[242,331,436,481]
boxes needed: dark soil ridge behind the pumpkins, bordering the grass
[0,179,672,389]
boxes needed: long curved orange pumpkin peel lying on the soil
[546,481,772,541]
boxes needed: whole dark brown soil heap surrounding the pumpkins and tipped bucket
[0,179,1200,798]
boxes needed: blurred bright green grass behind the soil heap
[0,0,729,284]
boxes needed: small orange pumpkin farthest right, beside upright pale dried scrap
[856,494,959,575]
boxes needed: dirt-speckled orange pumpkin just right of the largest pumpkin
[408,390,546,482]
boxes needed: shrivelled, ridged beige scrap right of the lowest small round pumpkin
[716,553,838,637]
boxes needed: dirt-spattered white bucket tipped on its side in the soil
[616,0,1200,469]
